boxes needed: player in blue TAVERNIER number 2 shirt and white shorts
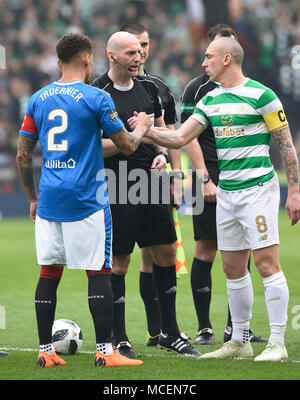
[17,33,151,367]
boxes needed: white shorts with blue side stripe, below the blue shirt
[35,207,112,270]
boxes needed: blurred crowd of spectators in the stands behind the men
[0,0,300,195]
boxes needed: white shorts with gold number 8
[216,174,280,251]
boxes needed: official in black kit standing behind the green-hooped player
[181,24,267,345]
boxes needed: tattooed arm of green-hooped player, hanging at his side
[272,126,299,191]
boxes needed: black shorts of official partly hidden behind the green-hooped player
[192,169,219,241]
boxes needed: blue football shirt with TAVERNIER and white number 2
[19,81,124,221]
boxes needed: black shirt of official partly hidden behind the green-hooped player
[180,74,218,169]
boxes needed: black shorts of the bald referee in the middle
[110,204,177,255]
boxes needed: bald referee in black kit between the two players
[94,32,200,358]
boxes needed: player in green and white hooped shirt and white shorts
[130,37,300,361]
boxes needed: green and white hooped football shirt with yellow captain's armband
[192,79,288,191]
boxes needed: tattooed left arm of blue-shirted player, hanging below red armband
[16,135,38,202]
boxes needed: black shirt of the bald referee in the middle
[93,73,162,172]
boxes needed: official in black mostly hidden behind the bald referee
[120,23,185,346]
